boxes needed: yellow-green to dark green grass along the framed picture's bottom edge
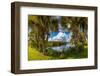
[28,46,88,60]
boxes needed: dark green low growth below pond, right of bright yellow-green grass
[44,46,88,59]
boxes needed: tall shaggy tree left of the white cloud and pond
[28,15,51,53]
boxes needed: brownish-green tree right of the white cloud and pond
[62,17,88,49]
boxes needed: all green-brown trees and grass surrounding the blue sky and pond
[28,15,88,60]
